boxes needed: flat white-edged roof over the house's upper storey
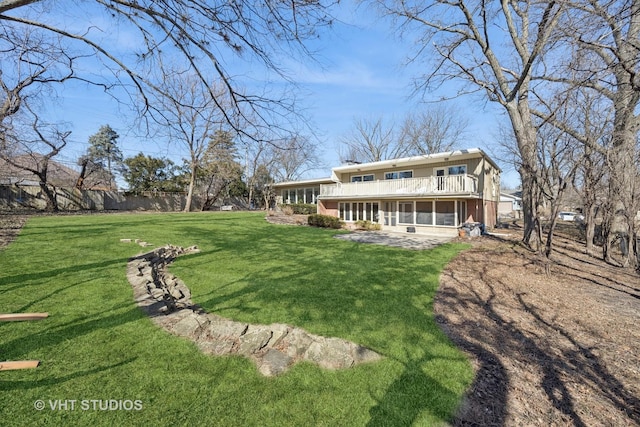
[332,148,501,175]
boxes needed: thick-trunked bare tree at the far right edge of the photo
[554,0,640,267]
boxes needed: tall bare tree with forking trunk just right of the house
[377,0,564,251]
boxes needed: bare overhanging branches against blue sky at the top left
[0,0,332,143]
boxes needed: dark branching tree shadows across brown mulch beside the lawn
[436,242,640,426]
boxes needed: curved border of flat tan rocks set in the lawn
[127,244,382,376]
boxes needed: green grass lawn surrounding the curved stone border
[0,213,473,426]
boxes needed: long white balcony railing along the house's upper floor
[319,175,478,198]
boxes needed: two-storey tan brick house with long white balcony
[274,148,501,234]
